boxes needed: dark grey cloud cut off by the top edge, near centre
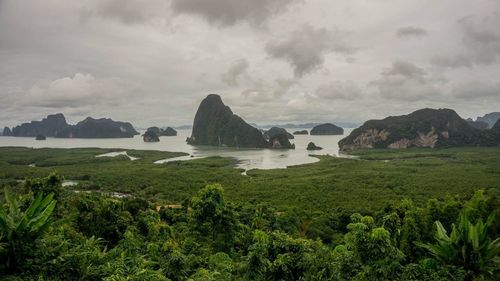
[171,0,299,26]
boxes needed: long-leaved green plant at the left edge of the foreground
[0,191,56,270]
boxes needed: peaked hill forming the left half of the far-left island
[12,113,69,137]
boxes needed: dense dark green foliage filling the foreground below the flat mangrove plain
[0,174,500,280]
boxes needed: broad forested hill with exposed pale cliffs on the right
[339,109,499,151]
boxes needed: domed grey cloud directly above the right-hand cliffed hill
[370,61,438,101]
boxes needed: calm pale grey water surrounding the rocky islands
[0,128,352,170]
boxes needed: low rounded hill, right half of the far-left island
[55,117,139,138]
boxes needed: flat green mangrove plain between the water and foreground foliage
[0,145,500,211]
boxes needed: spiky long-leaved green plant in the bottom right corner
[418,211,500,277]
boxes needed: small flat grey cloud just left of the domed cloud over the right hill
[315,81,362,100]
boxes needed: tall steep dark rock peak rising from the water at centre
[187,94,269,148]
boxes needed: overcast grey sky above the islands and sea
[0,0,500,127]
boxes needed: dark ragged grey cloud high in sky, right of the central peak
[266,24,355,77]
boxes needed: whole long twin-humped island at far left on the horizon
[4,113,139,138]
